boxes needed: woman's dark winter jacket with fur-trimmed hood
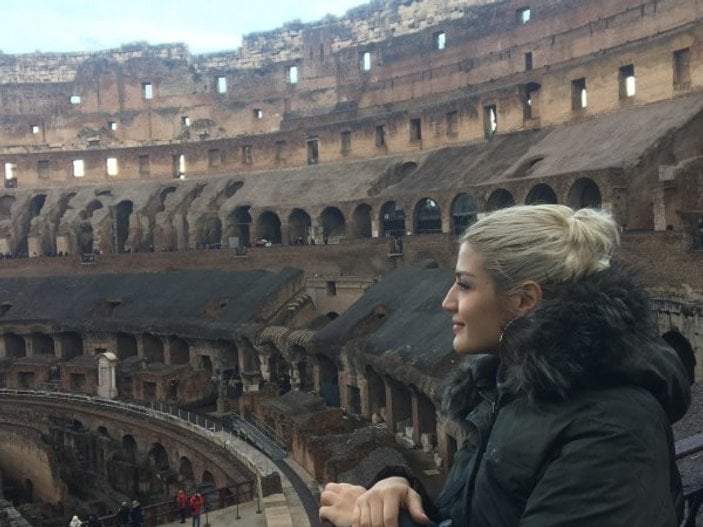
[376,269,690,527]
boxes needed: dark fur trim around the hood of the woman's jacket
[442,266,690,422]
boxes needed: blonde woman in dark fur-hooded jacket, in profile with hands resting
[320,205,690,527]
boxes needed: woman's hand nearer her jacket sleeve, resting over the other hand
[352,477,430,527]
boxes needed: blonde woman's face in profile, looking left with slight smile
[442,242,514,353]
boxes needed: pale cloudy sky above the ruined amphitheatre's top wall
[0,0,367,54]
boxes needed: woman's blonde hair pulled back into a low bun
[459,205,620,293]
